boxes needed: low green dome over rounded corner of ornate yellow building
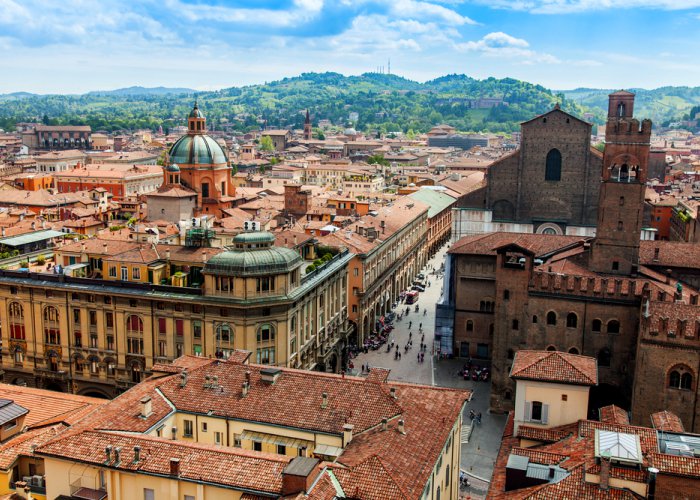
[204,244,302,276]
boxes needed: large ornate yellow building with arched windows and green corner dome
[0,232,351,397]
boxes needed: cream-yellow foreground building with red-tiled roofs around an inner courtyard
[36,351,471,500]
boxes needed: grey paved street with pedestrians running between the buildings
[353,240,506,499]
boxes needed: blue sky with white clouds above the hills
[0,0,700,93]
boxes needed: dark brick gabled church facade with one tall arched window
[452,104,602,241]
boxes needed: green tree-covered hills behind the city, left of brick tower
[0,73,583,132]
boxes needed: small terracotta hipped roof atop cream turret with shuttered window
[510,351,598,385]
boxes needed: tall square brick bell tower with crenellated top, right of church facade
[590,90,651,275]
